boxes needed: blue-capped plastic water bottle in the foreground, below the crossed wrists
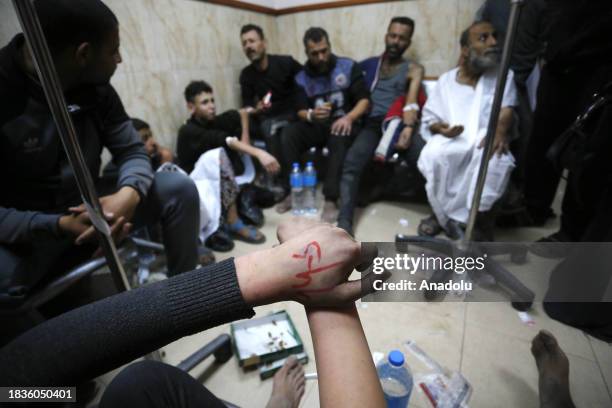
[376,350,412,408]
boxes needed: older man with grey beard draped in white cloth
[418,21,516,240]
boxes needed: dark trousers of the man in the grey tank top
[338,117,425,223]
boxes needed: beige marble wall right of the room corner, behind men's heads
[277,0,483,76]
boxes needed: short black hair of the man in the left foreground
[34,0,119,55]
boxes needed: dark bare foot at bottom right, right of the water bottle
[531,330,574,408]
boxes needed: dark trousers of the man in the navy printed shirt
[281,121,358,201]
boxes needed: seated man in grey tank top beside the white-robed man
[338,17,424,235]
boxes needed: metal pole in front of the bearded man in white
[464,0,524,243]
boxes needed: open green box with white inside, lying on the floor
[230,311,304,367]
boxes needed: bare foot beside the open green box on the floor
[266,356,306,408]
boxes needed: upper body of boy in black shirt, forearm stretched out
[176,81,280,175]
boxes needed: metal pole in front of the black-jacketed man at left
[13,0,130,290]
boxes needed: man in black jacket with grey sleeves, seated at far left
[0,0,199,310]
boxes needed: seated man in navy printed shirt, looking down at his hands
[277,27,370,222]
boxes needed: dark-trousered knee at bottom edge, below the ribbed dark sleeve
[99,361,226,408]
